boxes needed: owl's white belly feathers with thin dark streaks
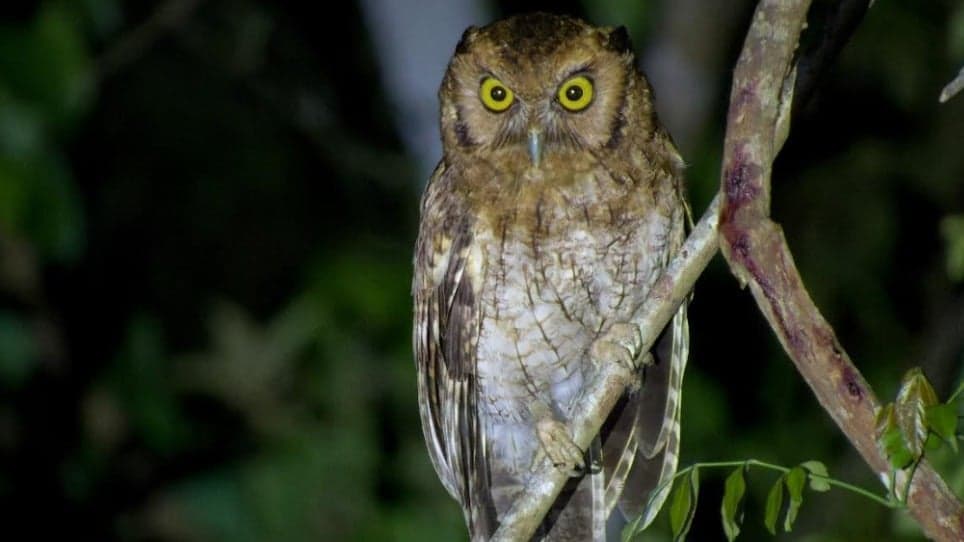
[475,190,670,472]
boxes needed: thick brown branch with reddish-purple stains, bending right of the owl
[720,0,964,541]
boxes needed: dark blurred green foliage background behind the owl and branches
[0,0,964,541]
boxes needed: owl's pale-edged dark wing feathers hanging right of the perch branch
[619,304,689,528]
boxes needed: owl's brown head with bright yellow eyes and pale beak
[439,13,654,168]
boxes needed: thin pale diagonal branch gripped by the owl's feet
[492,196,720,542]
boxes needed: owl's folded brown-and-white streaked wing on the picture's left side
[412,164,495,539]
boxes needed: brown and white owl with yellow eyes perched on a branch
[413,14,688,540]
